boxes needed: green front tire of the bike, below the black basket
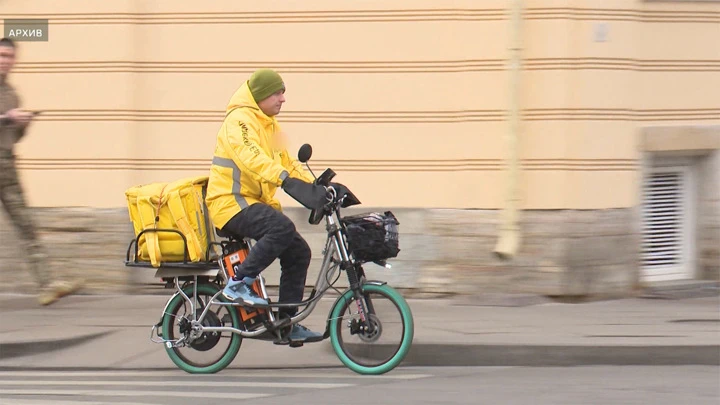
[330,284,415,375]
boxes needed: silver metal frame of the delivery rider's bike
[163,206,366,343]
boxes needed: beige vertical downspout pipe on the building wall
[493,0,523,260]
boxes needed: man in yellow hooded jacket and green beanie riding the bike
[206,69,326,341]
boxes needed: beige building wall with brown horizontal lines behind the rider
[0,0,720,291]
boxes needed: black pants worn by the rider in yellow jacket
[222,203,312,316]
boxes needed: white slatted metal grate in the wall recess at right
[642,171,684,267]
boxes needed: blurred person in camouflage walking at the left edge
[0,38,82,305]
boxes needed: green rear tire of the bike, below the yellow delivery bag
[162,284,242,374]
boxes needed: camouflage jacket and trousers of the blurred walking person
[0,72,50,288]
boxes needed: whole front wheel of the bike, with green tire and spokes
[330,284,414,374]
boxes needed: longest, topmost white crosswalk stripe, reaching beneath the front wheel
[0,369,431,381]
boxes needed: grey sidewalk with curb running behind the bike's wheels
[0,290,720,369]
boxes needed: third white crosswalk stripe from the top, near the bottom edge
[0,389,270,400]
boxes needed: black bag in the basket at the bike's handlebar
[342,211,400,262]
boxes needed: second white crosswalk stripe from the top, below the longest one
[0,380,352,389]
